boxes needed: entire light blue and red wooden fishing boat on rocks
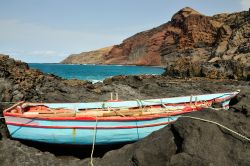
[3,91,239,145]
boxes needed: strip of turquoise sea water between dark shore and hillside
[29,63,164,82]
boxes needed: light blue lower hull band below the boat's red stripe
[8,125,168,145]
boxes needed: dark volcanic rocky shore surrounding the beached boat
[0,55,250,165]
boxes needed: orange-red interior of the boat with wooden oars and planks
[5,102,211,117]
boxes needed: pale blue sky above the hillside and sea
[0,0,250,63]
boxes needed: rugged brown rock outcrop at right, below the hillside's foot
[163,58,250,81]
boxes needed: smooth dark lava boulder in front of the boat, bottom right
[80,109,250,166]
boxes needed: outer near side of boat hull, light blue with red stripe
[6,116,178,145]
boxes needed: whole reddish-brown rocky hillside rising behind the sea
[63,7,250,66]
